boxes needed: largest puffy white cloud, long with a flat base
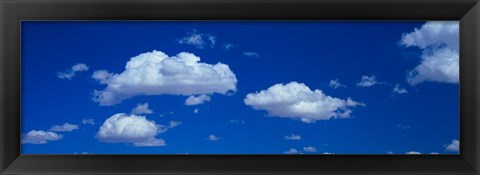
[92,50,237,106]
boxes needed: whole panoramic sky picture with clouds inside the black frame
[22,21,459,154]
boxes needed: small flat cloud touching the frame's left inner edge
[22,130,63,144]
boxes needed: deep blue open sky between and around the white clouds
[21,21,459,154]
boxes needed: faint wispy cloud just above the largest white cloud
[178,30,217,49]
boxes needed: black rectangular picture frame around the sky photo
[0,0,480,175]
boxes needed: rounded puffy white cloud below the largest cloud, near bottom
[96,113,171,146]
